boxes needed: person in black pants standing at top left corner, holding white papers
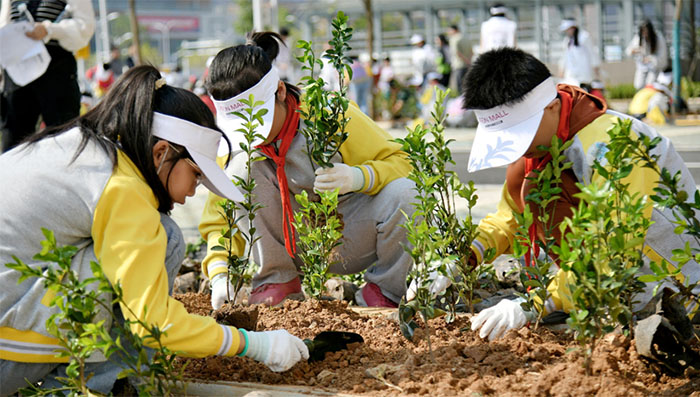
[0,0,95,152]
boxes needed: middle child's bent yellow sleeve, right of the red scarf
[340,102,411,195]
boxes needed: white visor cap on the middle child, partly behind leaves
[212,66,280,156]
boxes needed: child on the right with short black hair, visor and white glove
[463,48,700,339]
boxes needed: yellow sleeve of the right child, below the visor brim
[472,183,518,263]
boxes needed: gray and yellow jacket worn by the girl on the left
[0,128,239,363]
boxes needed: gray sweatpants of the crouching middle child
[231,140,416,302]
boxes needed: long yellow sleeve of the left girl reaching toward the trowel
[92,153,240,357]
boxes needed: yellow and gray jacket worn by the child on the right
[472,110,700,311]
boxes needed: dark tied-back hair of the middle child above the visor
[206,32,301,101]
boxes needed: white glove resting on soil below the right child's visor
[472,298,536,341]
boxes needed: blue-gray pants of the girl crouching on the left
[0,214,185,397]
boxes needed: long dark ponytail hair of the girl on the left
[27,65,231,213]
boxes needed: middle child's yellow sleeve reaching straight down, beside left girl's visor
[199,188,245,280]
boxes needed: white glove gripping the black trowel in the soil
[241,329,309,372]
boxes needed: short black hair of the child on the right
[462,47,551,109]
